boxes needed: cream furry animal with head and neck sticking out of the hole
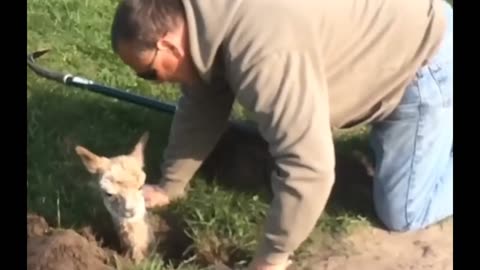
[75,132,155,263]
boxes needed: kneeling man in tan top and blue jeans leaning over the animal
[112,0,453,269]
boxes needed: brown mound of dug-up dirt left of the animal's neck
[27,214,114,270]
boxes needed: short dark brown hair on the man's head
[111,0,185,52]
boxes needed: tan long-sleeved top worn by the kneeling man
[161,0,445,262]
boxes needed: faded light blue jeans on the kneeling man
[371,3,453,231]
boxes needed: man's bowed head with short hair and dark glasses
[111,0,194,83]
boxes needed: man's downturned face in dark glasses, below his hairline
[118,42,182,83]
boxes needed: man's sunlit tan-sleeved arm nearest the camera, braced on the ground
[232,52,335,264]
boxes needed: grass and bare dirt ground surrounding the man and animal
[27,0,453,270]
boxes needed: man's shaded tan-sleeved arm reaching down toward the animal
[160,80,234,199]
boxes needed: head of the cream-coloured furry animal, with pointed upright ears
[75,132,149,220]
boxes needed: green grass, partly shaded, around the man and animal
[27,0,372,269]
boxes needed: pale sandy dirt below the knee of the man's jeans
[291,220,453,270]
